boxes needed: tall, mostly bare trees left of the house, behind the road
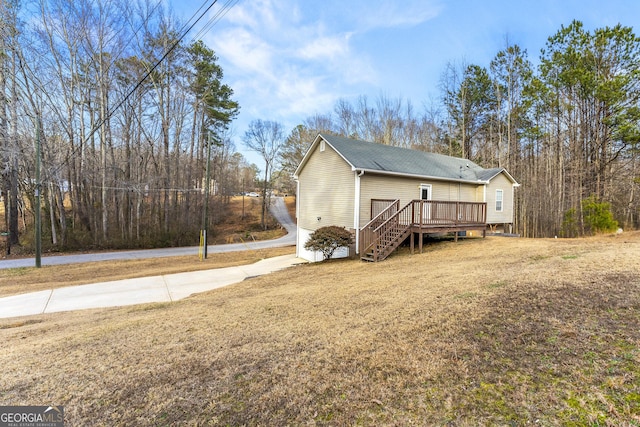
[0,0,257,254]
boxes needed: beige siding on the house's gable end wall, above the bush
[298,144,355,230]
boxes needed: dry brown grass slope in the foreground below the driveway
[0,233,640,426]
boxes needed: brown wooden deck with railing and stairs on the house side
[359,200,487,261]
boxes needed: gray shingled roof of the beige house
[320,134,515,183]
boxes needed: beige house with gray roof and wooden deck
[294,134,519,261]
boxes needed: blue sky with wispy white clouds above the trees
[172,0,640,166]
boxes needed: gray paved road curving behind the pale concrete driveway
[0,197,297,269]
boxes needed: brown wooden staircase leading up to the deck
[360,200,411,262]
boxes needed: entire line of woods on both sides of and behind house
[0,4,640,254]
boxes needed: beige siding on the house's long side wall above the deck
[360,173,482,227]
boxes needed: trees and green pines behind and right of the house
[281,21,640,237]
